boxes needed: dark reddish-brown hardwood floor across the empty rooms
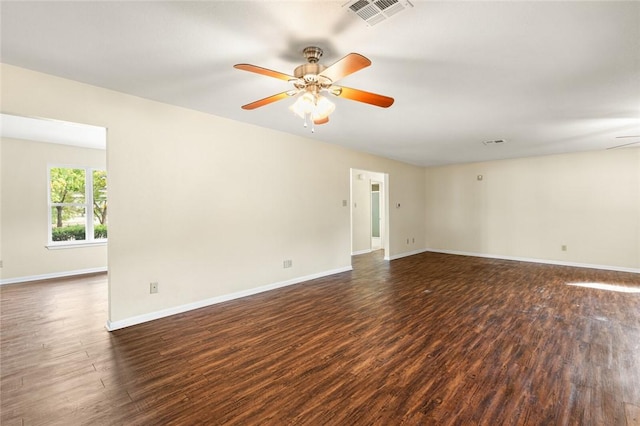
[0,252,640,426]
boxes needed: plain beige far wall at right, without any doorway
[425,149,640,270]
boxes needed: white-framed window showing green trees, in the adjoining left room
[49,167,107,246]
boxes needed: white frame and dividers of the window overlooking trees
[46,164,108,249]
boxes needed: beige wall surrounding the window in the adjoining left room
[0,139,107,283]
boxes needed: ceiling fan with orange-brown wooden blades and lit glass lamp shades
[234,46,394,131]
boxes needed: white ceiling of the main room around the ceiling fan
[0,0,640,165]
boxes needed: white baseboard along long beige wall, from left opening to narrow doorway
[106,265,353,331]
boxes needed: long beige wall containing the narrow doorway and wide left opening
[2,65,425,326]
